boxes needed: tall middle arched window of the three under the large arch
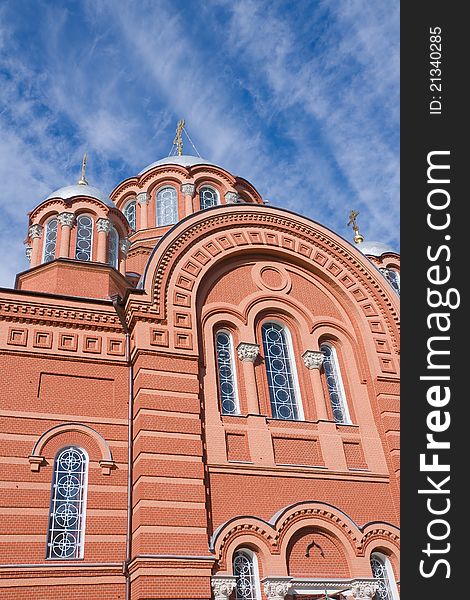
[261,322,303,421]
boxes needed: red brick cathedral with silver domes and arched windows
[0,155,399,600]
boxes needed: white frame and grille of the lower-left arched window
[46,446,89,560]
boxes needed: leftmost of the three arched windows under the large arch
[215,329,240,415]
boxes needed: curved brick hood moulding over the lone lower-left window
[28,423,115,475]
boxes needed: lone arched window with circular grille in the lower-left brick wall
[47,446,88,559]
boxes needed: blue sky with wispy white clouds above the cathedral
[0,0,399,287]
